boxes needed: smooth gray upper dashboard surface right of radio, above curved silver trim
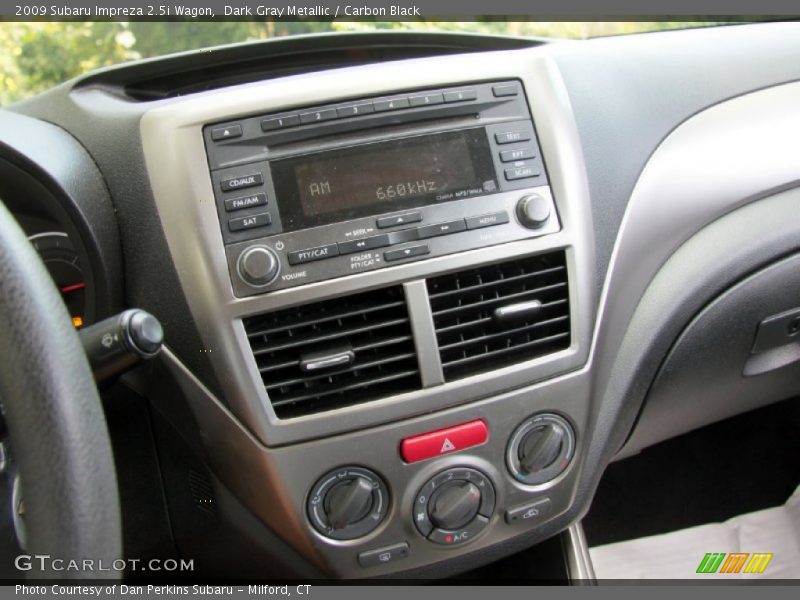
[552,23,800,297]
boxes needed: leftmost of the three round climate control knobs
[307,467,389,540]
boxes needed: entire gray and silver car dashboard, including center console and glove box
[0,24,800,578]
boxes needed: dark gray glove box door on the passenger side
[624,255,800,454]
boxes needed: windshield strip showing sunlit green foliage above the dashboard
[0,21,713,106]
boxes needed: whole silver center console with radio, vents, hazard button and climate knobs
[142,50,595,577]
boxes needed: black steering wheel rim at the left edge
[0,201,122,579]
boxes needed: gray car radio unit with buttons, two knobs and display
[203,80,560,297]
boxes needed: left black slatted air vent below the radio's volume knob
[244,286,421,419]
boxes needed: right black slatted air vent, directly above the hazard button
[428,251,570,381]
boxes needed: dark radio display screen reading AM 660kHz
[270,127,497,231]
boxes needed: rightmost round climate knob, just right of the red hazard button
[506,414,575,485]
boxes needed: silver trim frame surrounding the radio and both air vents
[140,50,595,445]
